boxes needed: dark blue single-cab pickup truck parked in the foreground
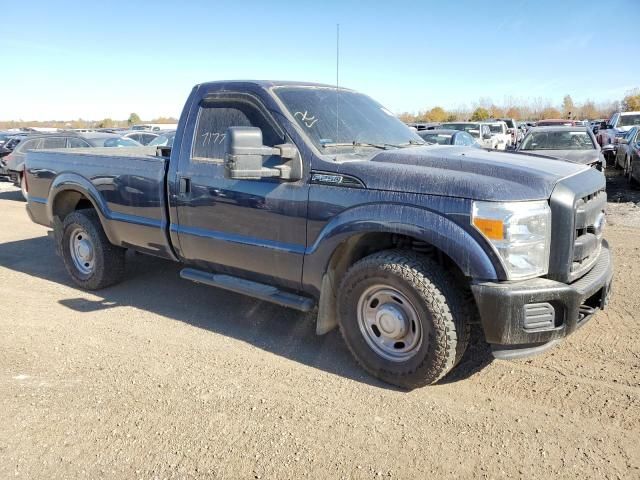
[26,81,613,388]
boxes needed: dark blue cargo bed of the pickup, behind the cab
[26,147,173,258]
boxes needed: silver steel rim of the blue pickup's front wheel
[358,285,423,362]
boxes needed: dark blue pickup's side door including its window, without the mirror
[172,93,309,289]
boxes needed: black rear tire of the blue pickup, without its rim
[56,209,125,290]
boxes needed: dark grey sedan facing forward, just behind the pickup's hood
[516,126,605,170]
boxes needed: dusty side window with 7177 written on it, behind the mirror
[192,98,284,162]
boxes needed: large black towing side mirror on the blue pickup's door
[224,127,302,181]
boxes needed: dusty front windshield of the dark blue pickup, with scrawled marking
[274,87,424,149]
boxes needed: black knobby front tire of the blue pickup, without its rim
[338,250,475,389]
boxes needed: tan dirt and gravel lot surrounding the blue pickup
[0,173,640,479]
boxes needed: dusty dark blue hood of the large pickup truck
[336,146,589,201]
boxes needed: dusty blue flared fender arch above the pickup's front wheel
[303,203,498,295]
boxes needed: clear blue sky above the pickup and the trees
[0,0,640,120]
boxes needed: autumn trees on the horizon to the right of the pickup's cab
[399,88,640,123]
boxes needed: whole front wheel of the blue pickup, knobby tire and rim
[338,250,469,388]
